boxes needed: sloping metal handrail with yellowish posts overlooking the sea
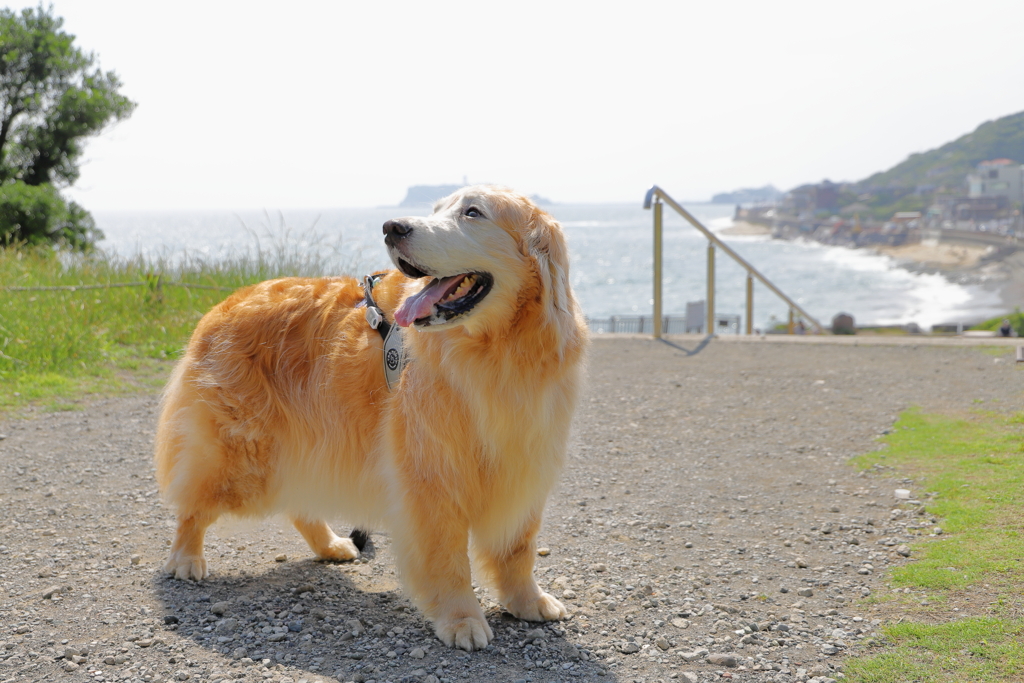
[643,185,824,338]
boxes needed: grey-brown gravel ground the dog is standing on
[0,338,1021,683]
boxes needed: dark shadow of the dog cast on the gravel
[155,544,615,683]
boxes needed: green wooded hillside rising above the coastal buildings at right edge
[856,112,1024,191]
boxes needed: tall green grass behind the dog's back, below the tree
[0,227,360,411]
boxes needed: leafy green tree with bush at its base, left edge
[0,5,135,247]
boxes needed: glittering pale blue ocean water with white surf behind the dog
[95,202,1004,328]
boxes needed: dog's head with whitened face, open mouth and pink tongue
[384,185,577,334]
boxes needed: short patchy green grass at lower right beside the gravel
[845,411,1024,683]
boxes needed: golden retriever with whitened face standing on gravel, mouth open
[156,185,587,650]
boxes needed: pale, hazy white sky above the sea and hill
[41,0,1024,211]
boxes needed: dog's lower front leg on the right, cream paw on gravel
[473,514,568,622]
